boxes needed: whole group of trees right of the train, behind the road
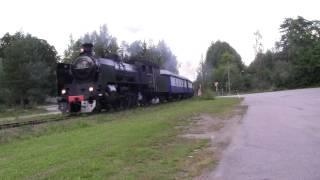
[195,16,320,93]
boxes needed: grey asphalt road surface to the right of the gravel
[208,88,320,180]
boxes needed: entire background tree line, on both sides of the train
[0,17,320,105]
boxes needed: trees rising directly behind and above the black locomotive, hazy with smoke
[63,25,178,73]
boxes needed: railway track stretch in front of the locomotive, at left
[0,115,72,130]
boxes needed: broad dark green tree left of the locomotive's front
[1,32,58,105]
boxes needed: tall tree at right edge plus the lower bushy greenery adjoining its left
[248,17,320,89]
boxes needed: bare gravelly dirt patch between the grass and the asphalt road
[182,102,247,180]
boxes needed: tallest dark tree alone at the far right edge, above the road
[276,16,320,87]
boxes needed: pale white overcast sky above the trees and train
[0,0,320,80]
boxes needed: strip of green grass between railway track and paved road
[0,98,240,179]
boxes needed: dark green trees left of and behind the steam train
[0,25,178,106]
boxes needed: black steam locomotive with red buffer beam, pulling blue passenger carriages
[57,43,193,112]
